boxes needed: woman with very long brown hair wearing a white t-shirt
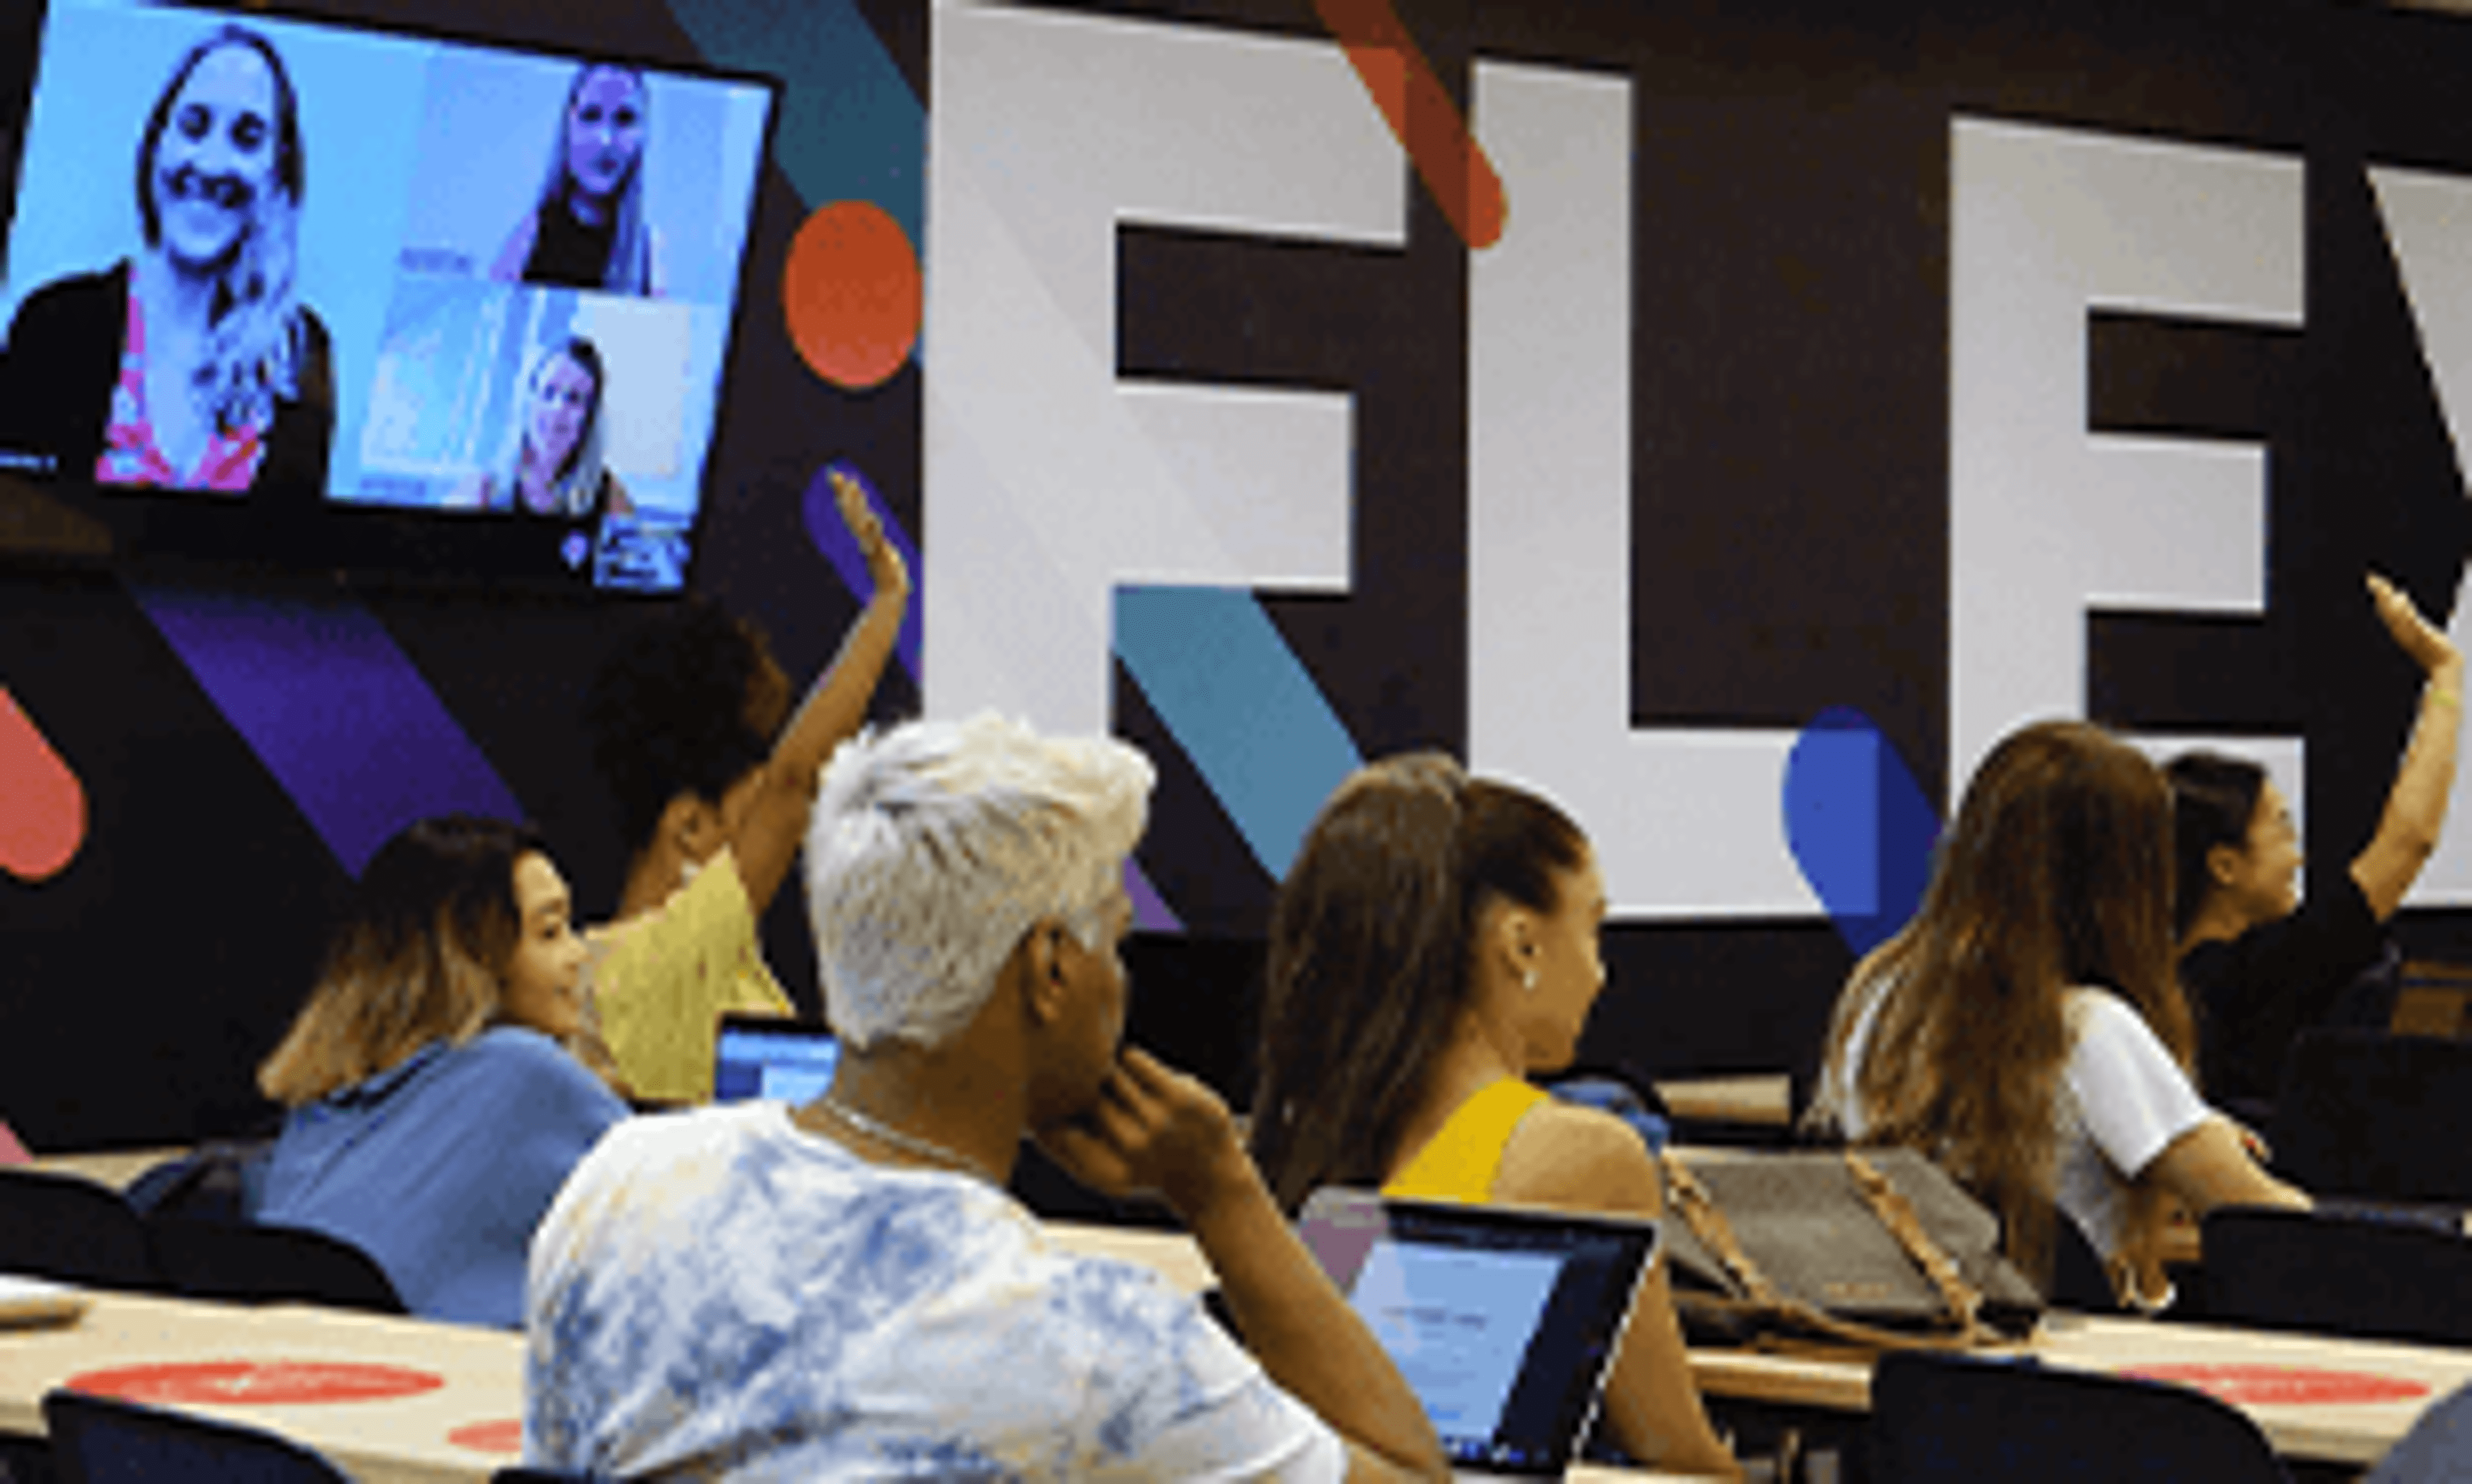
[1815,721,2307,1309]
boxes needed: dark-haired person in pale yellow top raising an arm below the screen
[586,472,910,1101]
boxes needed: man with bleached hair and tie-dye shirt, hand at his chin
[524,716,1444,1479]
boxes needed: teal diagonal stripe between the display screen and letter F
[670,0,927,242]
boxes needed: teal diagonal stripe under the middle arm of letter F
[1115,588,1362,876]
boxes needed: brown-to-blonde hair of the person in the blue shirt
[257,815,548,1106]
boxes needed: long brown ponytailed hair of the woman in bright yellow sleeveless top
[1251,753,1587,1212]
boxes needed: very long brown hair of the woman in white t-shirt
[1819,721,2198,1272]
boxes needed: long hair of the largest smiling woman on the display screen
[138,24,306,432]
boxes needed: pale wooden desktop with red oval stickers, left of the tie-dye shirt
[0,1292,524,1484]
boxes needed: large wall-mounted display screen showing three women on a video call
[0,0,776,593]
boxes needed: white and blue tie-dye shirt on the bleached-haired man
[524,1104,1347,1479]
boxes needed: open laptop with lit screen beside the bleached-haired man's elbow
[1298,1188,1656,1481]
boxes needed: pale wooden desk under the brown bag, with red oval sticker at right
[1691,1313,2472,1467]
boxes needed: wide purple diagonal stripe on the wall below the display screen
[129,583,524,876]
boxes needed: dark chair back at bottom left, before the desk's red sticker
[42,1390,351,1484]
